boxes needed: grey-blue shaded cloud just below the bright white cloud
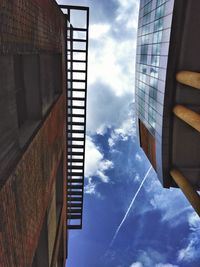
[87,83,133,134]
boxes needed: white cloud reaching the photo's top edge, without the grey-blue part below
[88,1,138,96]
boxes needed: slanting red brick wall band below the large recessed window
[0,96,64,267]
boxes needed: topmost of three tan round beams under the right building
[176,71,200,89]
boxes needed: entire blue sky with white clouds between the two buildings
[56,0,200,267]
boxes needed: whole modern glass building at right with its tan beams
[135,0,200,215]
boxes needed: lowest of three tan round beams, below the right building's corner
[170,169,200,217]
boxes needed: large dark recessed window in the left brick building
[14,53,63,147]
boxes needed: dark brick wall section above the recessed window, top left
[0,0,64,54]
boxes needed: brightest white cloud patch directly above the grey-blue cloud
[88,37,136,96]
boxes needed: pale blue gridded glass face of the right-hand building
[136,0,174,184]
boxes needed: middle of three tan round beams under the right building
[173,105,200,132]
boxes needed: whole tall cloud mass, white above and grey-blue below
[87,0,138,138]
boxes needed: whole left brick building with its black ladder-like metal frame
[0,0,88,267]
